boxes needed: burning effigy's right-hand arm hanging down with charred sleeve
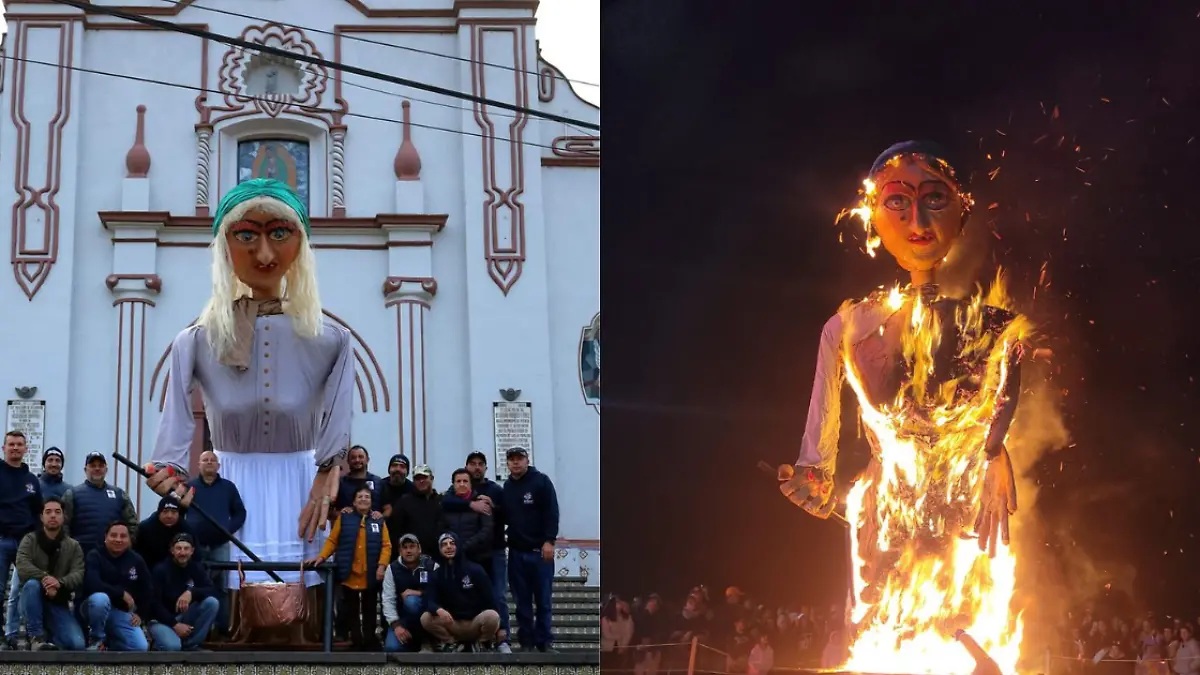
[974,345,1024,557]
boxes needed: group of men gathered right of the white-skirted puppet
[321,446,559,653]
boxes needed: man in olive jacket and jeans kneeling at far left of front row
[17,497,84,651]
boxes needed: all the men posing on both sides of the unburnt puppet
[0,431,559,653]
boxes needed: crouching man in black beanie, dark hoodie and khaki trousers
[421,532,500,652]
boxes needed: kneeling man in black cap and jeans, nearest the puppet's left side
[150,532,221,651]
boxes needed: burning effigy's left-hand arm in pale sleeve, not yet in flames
[779,312,845,518]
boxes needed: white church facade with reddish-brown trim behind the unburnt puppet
[0,0,600,583]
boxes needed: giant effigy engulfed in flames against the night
[779,142,1030,674]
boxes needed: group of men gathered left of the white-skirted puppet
[0,431,220,651]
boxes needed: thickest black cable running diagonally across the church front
[45,0,600,131]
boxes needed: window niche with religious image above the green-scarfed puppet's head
[214,115,329,217]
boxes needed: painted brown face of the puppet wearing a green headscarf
[226,210,304,298]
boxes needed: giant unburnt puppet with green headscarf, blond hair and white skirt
[145,179,354,589]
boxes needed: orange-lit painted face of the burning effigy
[871,156,962,271]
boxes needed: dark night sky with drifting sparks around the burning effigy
[601,0,1200,616]
